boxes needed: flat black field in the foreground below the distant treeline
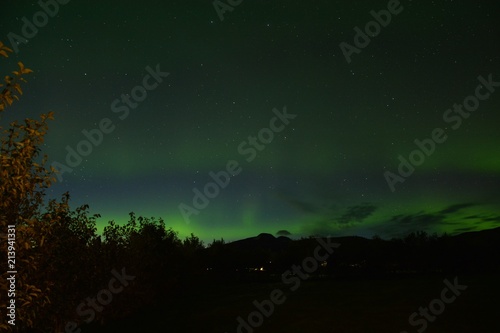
[84,276,500,333]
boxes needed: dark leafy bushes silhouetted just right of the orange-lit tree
[1,194,204,332]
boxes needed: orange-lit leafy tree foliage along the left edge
[0,43,54,330]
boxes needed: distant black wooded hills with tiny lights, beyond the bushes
[197,228,500,280]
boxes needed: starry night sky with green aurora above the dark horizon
[0,0,500,242]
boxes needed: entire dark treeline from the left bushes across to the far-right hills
[3,194,500,332]
